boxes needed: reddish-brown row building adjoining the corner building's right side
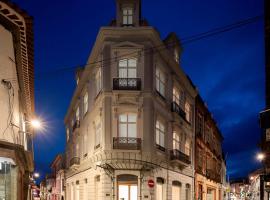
[195,95,226,200]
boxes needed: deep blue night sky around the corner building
[11,0,264,179]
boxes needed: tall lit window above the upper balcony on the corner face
[118,58,137,78]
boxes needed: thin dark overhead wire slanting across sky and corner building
[11,15,264,81]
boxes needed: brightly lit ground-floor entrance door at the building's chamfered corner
[117,174,138,200]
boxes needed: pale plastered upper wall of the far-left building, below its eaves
[0,24,25,146]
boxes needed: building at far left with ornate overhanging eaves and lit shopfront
[0,0,34,200]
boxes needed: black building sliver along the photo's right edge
[260,0,270,200]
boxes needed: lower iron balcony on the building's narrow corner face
[113,137,142,150]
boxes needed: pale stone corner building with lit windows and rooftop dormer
[65,0,197,200]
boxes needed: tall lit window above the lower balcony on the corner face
[119,113,137,138]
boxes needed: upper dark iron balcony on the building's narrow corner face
[113,78,141,90]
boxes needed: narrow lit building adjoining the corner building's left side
[51,154,65,200]
